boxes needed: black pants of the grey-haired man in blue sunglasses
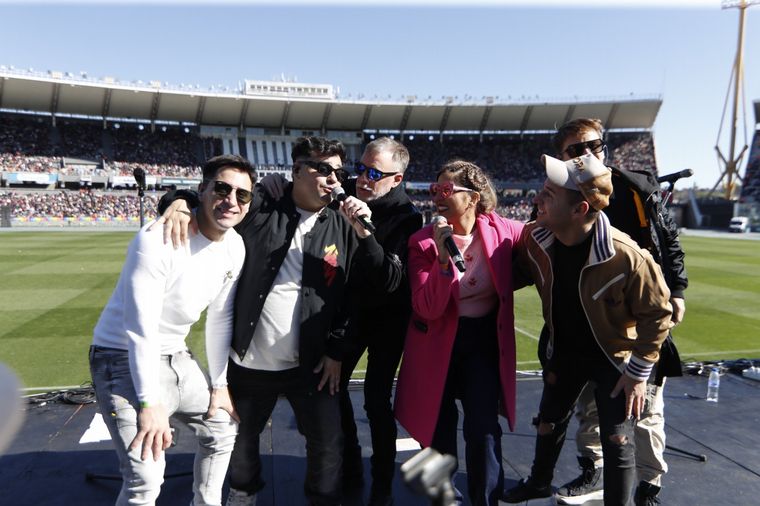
[340,326,406,494]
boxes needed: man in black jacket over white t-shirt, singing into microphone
[159,137,368,506]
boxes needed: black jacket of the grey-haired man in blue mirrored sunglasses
[344,179,422,341]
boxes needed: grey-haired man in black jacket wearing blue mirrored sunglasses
[340,137,422,506]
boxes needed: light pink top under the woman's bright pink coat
[452,229,499,318]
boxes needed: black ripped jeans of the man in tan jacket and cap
[531,354,636,506]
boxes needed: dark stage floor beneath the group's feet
[0,374,760,506]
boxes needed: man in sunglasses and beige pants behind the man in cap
[508,118,688,506]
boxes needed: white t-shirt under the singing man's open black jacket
[236,209,319,371]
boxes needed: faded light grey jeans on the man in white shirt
[90,346,237,506]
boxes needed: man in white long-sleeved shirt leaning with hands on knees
[90,156,254,505]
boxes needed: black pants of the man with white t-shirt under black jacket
[227,361,343,506]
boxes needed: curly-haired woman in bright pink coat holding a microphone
[395,160,523,505]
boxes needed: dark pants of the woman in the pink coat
[430,314,504,506]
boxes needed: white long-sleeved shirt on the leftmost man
[93,225,245,404]
